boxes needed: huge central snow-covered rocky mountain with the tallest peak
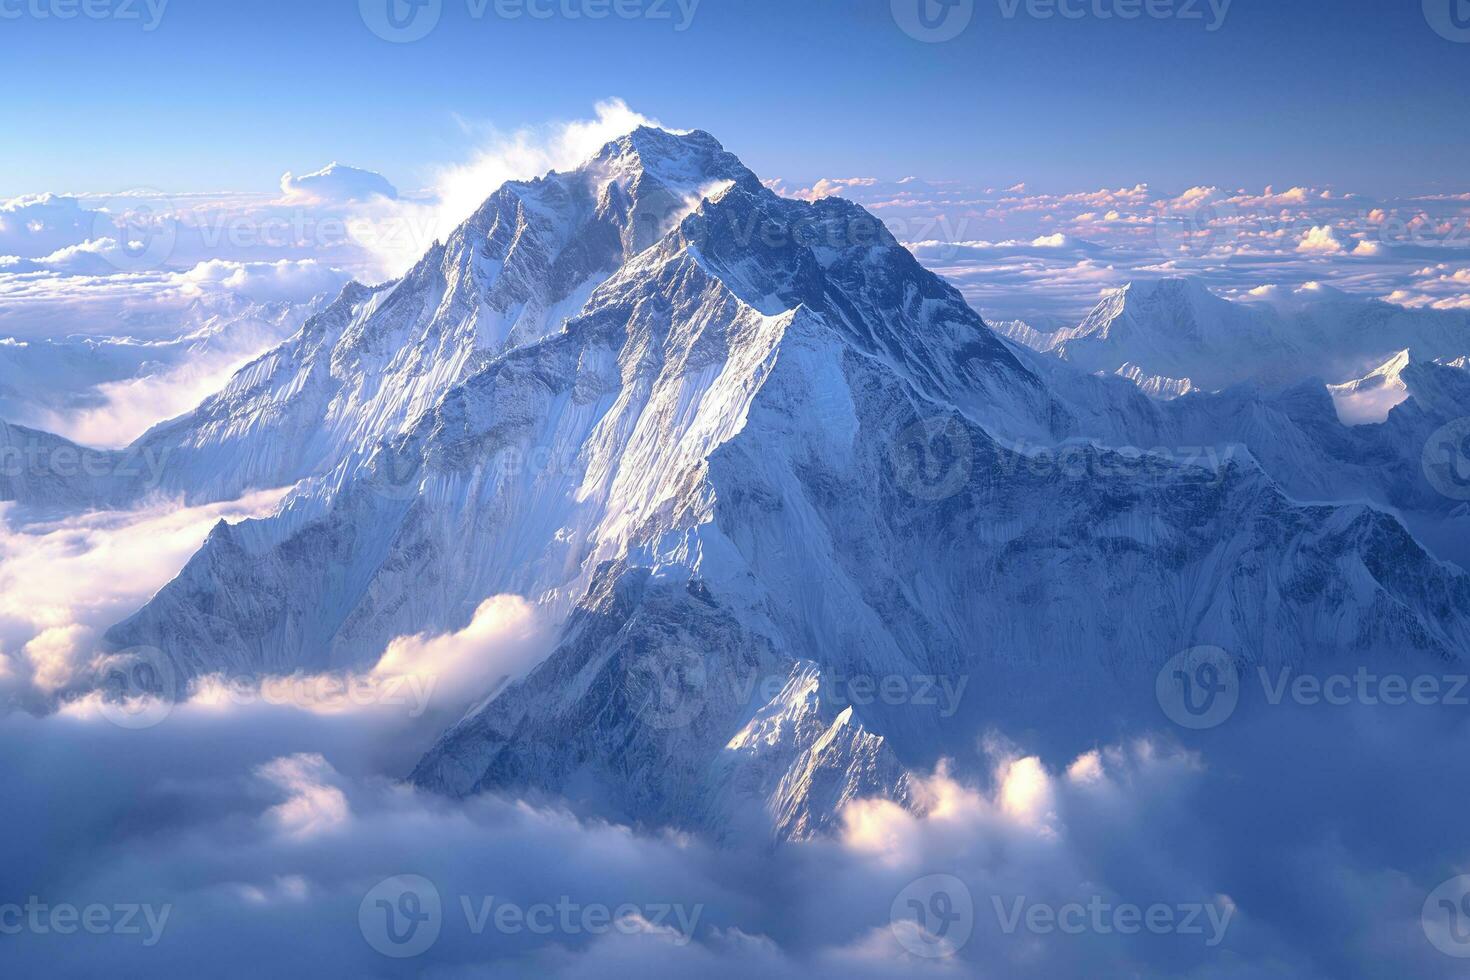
[88,129,1470,836]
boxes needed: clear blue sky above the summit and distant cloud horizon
[0,0,1470,197]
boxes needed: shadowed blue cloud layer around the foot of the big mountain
[0,705,1470,980]
